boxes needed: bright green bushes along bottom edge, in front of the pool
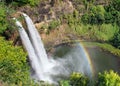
[60,70,120,86]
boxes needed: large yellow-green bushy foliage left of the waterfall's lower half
[0,37,30,84]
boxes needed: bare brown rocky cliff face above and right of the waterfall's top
[18,0,74,23]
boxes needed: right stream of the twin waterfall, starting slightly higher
[23,13,49,70]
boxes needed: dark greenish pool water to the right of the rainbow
[86,47,120,75]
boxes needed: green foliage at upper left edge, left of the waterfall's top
[0,2,15,36]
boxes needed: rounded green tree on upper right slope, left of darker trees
[81,5,105,24]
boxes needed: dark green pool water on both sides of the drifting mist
[53,44,120,76]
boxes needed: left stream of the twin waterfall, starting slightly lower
[14,18,43,79]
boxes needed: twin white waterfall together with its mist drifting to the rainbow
[14,13,91,83]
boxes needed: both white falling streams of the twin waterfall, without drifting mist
[14,13,51,81]
